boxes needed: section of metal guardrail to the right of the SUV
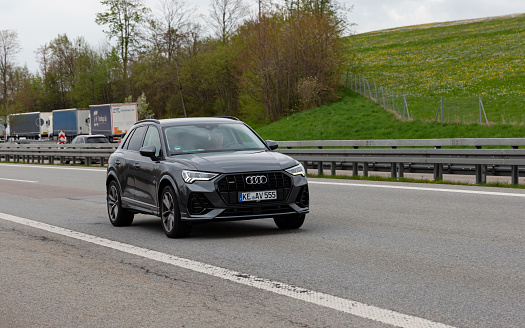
[279,138,525,184]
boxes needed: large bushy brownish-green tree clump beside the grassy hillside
[234,0,344,121]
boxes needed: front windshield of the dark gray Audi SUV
[164,123,266,155]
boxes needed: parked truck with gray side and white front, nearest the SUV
[89,103,138,141]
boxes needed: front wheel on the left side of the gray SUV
[160,186,191,238]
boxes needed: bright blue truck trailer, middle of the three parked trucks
[53,108,89,141]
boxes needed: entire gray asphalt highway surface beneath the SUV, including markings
[0,164,525,327]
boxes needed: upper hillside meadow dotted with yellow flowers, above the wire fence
[346,14,525,124]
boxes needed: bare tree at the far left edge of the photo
[0,30,20,121]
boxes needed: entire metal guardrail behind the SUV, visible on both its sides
[0,138,525,184]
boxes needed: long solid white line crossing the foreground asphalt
[0,213,453,328]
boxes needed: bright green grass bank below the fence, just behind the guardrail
[256,91,525,140]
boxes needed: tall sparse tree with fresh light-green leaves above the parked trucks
[95,0,149,79]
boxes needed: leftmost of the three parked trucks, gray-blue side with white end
[7,112,53,139]
